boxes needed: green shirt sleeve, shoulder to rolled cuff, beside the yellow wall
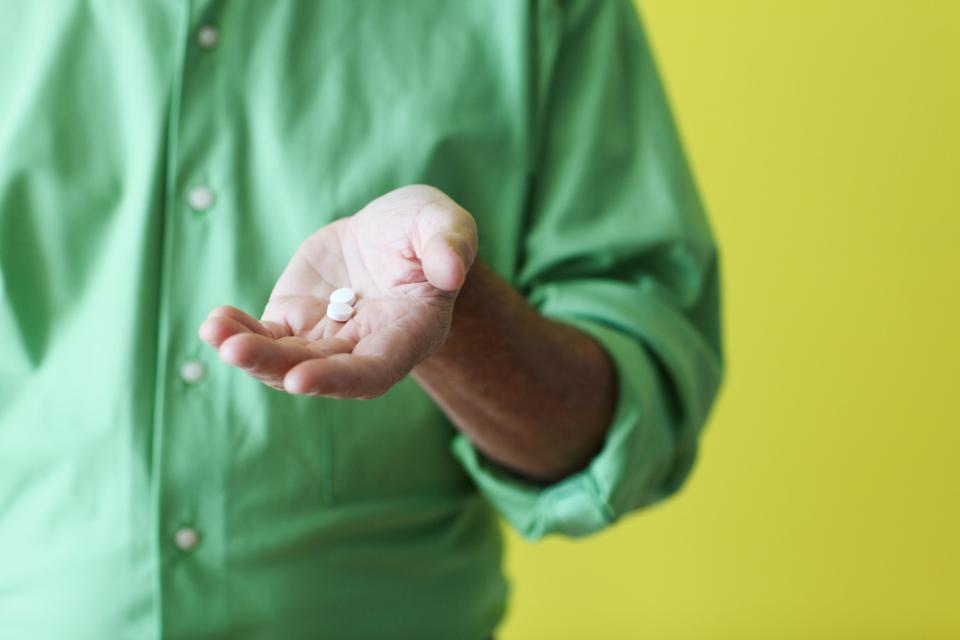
[452,0,722,540]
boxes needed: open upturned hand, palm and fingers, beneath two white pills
[200,186,476,397]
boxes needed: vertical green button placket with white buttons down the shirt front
[153,1,225,637]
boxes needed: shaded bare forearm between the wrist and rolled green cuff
[413,260,616,482]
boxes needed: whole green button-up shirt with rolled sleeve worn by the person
[0,0,721,640]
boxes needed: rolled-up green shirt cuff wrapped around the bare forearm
[451,288,675,540]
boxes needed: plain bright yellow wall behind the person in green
[498,0,960,640]
